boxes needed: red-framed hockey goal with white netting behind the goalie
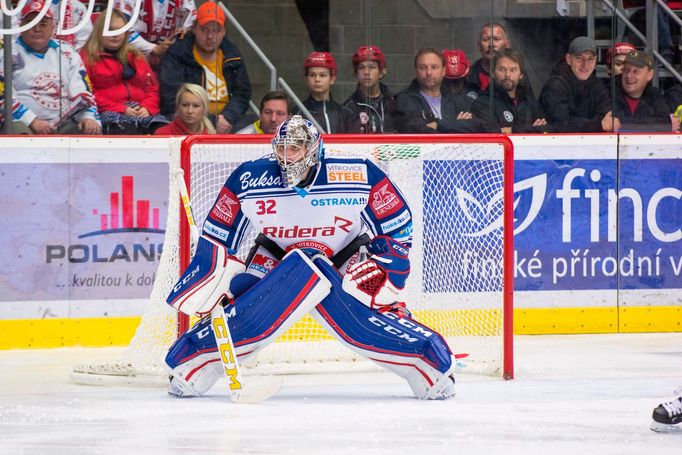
[72,135,513,386]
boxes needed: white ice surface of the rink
[0,333,682,455]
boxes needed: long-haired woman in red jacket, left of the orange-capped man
[80,9,168,134]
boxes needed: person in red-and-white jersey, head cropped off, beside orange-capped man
[115,0,197,68]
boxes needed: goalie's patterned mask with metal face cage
[272,115,323,188]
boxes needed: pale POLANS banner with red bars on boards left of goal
[0,140,168,319]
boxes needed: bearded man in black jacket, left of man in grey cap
[472,48,549,134]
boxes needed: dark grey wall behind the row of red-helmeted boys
[222,0,586,109]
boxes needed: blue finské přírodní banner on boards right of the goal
[514,136,682,306]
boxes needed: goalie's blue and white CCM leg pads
[166,251,454,399]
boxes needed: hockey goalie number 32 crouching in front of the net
[166,116,455,399]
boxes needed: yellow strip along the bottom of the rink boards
[0,306,682,350]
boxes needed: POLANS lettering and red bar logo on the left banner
[45,175,166,264]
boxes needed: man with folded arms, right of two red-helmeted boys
[395,48,485,133]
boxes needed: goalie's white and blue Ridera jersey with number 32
[203,156,412,257]
